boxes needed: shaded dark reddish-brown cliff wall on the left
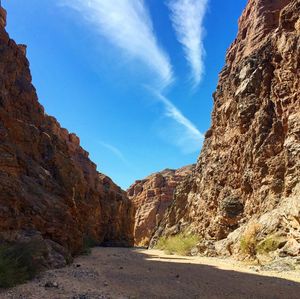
[0,8,133,268]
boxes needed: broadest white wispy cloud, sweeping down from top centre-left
[61,0,173,86]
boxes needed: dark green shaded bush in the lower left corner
[0,243,39,288]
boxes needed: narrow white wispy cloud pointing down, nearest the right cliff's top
[167,0,208,87]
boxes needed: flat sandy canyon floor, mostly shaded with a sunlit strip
[0,248,300,299]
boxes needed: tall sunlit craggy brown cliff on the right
[152,0,300,255]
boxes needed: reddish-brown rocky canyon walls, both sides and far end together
[0,0,300,296]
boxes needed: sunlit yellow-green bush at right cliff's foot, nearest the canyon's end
[156,233,199,255]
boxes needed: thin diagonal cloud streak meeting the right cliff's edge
[146,87,204,153]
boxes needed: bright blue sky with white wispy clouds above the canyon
[2,0,247,189]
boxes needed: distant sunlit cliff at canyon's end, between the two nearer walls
[127,165,194,246]
